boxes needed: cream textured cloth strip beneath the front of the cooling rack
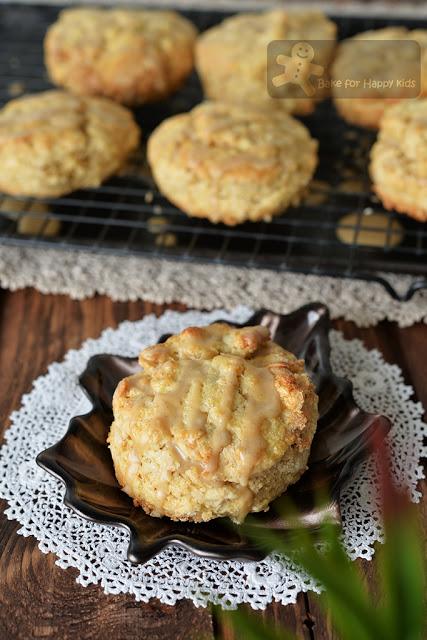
[0,247,427,327]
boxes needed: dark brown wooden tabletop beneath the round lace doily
[0,290,427,640]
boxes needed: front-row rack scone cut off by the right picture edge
[370,99,427,222]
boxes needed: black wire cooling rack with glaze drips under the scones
[0,5,427,300]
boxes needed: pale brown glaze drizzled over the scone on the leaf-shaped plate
[128,328,281,518]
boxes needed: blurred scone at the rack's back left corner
[45,8,197,105]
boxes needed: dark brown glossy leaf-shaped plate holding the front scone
[37,303,390,563]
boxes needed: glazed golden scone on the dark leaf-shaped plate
[108,323,318,522]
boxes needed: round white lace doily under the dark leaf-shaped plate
[0,307,426,608]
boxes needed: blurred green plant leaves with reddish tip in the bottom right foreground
[239,452,426,640]
